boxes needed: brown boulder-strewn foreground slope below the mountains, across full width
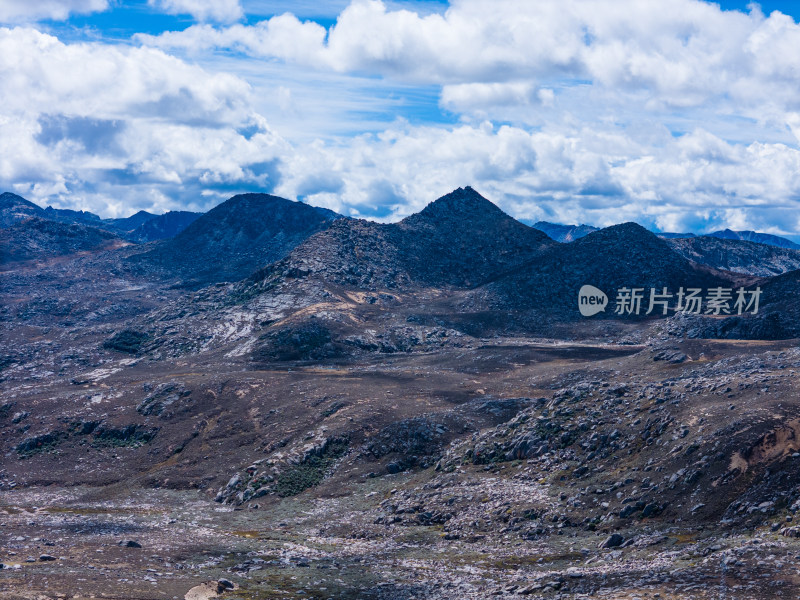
[0,333,800,598]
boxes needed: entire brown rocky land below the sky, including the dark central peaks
[0,188,800,600]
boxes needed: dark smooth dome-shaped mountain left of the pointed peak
[129,194,339,287]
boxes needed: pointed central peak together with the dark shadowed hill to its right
[251,187,741,326]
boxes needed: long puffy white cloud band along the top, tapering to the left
[141,0,800,106]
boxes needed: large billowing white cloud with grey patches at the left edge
[0,28,286,214]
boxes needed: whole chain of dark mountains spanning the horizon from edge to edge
[0,187,800,298]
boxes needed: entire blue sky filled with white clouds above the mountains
[0,0,800,236]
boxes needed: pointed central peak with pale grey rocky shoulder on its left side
[254,187,555,289]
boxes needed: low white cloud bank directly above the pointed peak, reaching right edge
[270,122,800,233]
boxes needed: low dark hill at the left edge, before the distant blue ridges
[0,217,124,266]
